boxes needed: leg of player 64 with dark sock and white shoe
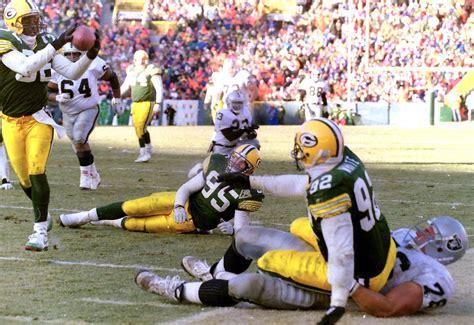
[71,107,100,190]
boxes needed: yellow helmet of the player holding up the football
[3,0,45,36]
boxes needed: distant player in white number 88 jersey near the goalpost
[298,69,329,121]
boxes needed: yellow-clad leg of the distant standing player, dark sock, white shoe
[132,102,153,162]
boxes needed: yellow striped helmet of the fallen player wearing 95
[226,144,261,176]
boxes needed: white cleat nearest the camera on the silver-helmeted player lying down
[135,270,185,302]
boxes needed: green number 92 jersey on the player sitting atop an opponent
[307,147,390,279]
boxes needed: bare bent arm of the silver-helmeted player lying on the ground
[352,282,423,317]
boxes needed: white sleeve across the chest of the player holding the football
[2,44,55,76]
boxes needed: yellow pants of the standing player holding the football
[1,114,54,187]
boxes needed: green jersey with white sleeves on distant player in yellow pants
[127,64,161,102]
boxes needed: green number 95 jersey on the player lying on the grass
[189,154,264,230]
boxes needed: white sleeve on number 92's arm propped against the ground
[321,212,354,307]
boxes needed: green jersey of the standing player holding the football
[0,29,54,117]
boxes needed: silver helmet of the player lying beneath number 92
[404,216,469,265]
